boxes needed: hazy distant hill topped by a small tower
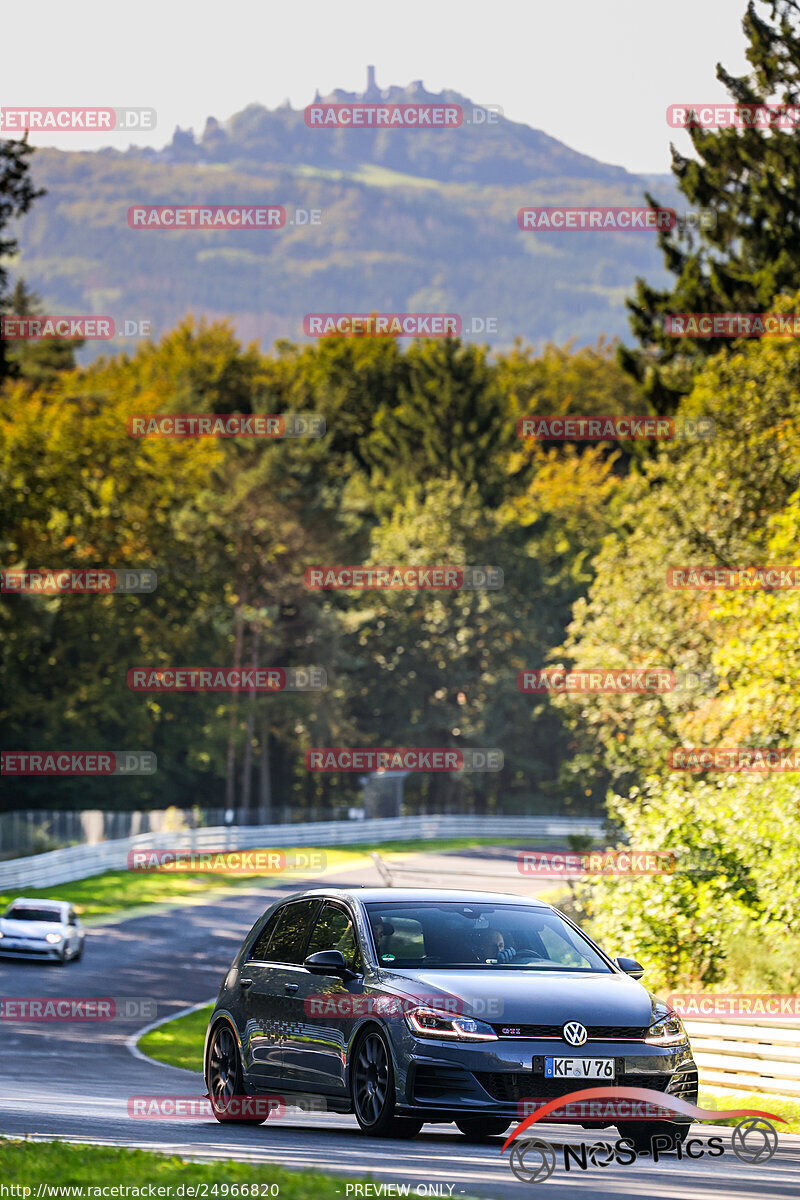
[16,69,678,359]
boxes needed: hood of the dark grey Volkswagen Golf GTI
[371,967,652,1027]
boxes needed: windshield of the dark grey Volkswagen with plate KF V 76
[367,900,612,974]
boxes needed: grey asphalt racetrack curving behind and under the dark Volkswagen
[0,848,800,1200]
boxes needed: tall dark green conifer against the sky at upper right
[620,0,800,413]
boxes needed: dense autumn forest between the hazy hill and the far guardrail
[0,320,636,814]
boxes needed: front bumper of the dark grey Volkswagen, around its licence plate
[397,1038,697,1124]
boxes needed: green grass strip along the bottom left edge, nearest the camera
[0,1138,365,1200]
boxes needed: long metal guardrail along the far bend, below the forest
[0,816,603,892]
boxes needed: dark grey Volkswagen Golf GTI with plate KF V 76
[205,888,697,1145]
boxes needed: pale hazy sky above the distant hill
[0,0,746,172]
